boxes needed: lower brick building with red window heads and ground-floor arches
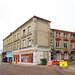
[50,29,75,60]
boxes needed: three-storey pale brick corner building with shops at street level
[3,16,51,64]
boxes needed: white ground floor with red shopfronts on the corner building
[13,48,48,65]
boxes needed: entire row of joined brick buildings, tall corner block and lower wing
[2,16,75,64]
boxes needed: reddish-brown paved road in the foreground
[0,63,75,75]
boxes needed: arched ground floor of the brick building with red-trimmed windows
[54,51,75,60]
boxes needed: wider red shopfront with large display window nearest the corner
[21,50,34,63]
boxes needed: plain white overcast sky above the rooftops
[0,0,75,49]
